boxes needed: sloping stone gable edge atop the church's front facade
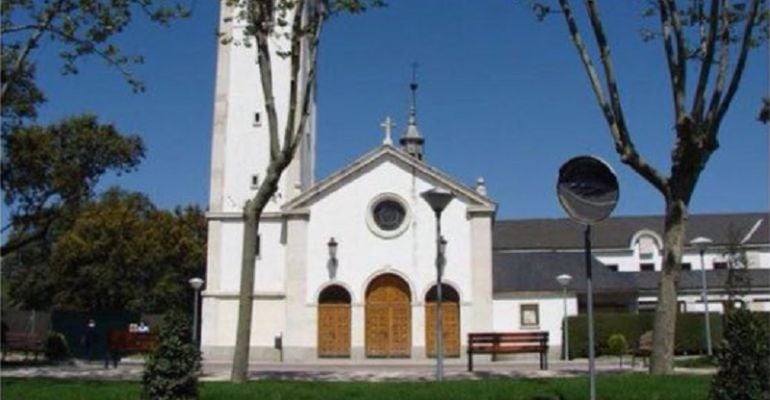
[283,144,497,212]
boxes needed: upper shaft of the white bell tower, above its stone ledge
[209,3,316,216]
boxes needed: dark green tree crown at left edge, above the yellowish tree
[0,115,144,256]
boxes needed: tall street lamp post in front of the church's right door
[420,188,454,381]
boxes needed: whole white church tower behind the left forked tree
[201,1,315,360]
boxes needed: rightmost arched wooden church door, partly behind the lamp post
[425,284,460,357]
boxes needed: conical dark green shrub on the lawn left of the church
[142,311,201,400]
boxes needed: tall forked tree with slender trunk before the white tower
[222,0,383,382]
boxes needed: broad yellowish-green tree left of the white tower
[3,188,206,312]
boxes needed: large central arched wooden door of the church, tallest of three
[365,274,412,357]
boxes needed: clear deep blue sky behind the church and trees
[33,0,769,218]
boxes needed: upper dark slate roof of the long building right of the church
[493,213,770,251]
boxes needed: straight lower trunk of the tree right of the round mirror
[650,199,687,374]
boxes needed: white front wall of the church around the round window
[306,157,473,304]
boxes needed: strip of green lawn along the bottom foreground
[2,374,710,400]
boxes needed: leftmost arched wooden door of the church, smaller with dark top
[318,285,350,357]
